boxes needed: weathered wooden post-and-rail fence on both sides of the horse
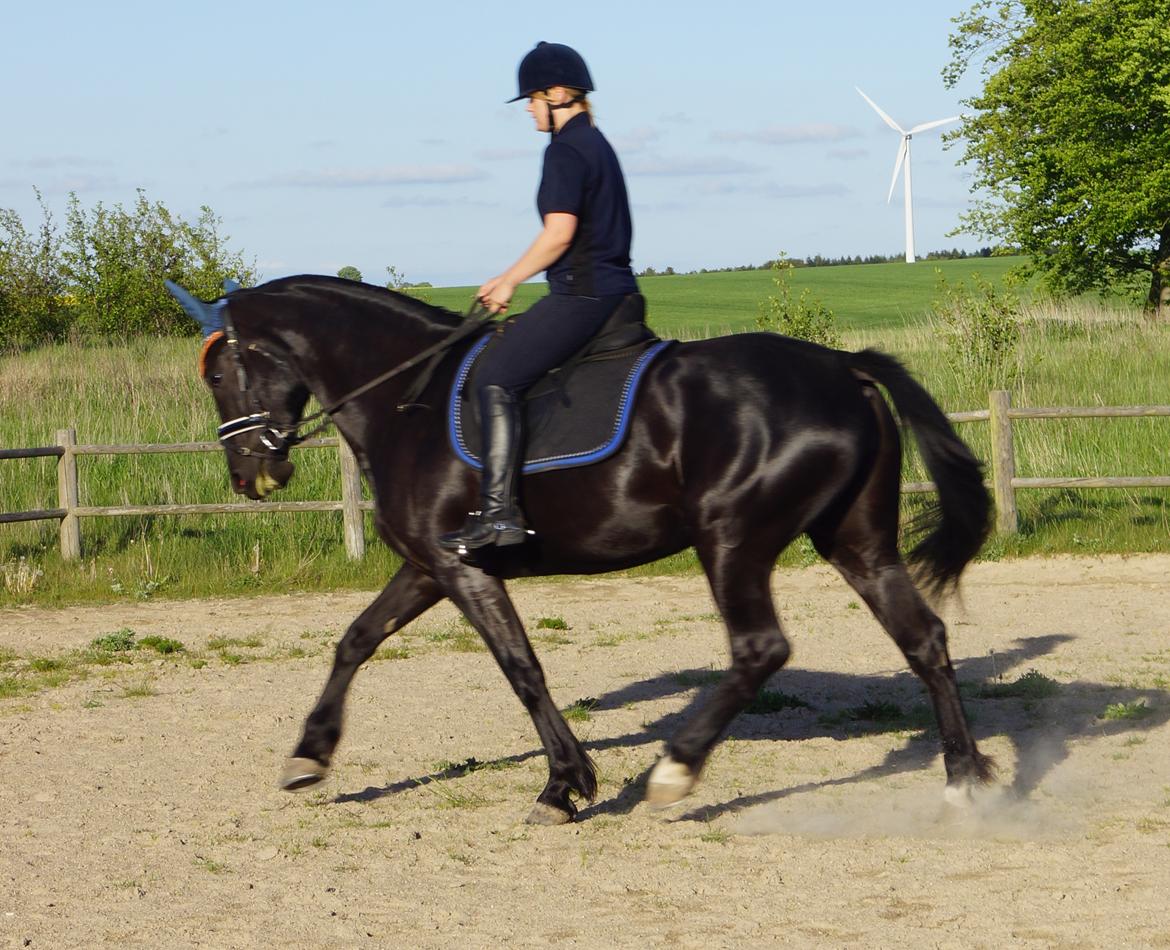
[0,390,1170,560]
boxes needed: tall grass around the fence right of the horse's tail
[847,302,1170,555]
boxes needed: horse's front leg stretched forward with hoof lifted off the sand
[280,564,443,792]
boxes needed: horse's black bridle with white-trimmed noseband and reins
[215,301,493,461]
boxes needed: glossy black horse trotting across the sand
[177,277,993,824]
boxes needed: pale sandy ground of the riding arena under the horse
[0,557,1170,948]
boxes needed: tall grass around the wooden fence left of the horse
[0,339,397,603]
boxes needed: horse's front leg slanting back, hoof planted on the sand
[443,565,597,825]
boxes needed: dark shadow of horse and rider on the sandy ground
[332,634,1170,821]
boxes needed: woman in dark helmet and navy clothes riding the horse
[440,42,638,550]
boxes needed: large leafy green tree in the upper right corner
[943,0,1170,317]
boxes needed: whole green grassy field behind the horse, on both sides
[0,259,1170,605]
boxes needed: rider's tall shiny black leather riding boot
[439,386,528,552]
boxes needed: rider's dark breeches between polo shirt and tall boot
[475,294,625,405]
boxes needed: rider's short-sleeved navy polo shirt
[536,113,638,297]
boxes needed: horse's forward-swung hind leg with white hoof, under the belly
[646,545,791,807]
